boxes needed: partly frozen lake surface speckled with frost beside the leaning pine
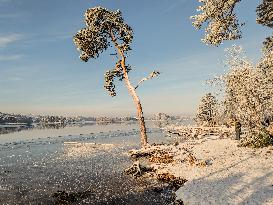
[0,122,171,205]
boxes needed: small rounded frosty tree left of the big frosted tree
[195,93,218,126]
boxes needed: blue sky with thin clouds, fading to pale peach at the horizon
[0,0,272,116]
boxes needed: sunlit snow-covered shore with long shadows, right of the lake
[131,136,273,205]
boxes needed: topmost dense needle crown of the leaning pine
[73,7,133,61]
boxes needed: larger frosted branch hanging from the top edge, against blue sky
[191,0,243,46]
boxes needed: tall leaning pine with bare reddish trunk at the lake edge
[73,7,159,147]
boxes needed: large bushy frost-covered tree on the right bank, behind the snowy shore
[212,46,273,147]
